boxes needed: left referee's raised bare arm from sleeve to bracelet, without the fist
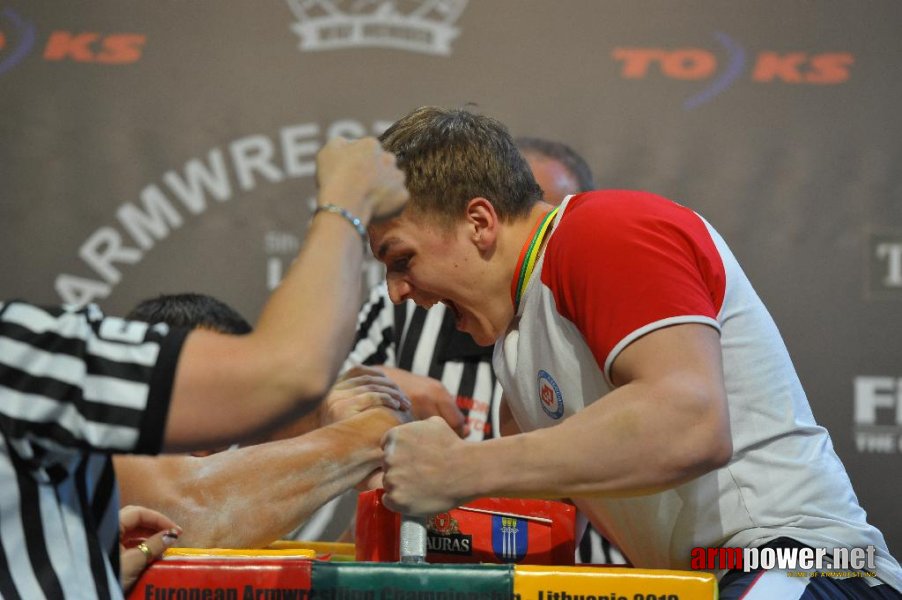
[166,215,363,451]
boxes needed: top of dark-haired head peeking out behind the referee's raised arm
[125,294,252,334]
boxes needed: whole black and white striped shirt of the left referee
[0,301,186,600]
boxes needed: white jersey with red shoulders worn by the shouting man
[494,191,902,588]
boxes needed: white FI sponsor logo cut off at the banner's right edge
[853,375,902,454]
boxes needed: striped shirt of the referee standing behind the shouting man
[345,283,626,564]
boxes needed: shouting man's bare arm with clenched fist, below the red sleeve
[383,324,732,514]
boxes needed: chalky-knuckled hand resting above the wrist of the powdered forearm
[317,365,411,427]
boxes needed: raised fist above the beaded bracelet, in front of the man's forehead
[316,137,408,224]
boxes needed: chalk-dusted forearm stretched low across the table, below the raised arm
[113,408,406,548]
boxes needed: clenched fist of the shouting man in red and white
[382,417,468,515]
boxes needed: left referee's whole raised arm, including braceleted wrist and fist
[164,138,407,451]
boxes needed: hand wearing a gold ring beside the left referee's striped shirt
[119,506,182,592]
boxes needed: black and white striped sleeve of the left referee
[0,301,186,466]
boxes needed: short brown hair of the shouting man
[379,106,542,223]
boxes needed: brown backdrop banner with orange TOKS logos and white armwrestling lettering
[0,0,902,555]
